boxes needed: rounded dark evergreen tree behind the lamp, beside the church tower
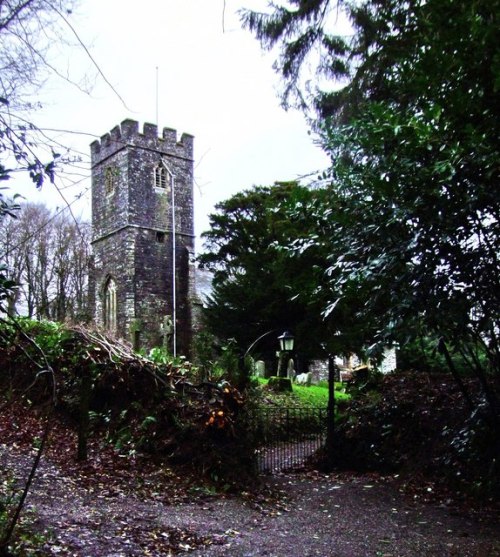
[199,182,376,364]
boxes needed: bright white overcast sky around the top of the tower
[12,0,328,248]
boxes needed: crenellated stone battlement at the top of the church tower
[90,119,194,166]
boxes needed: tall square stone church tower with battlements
[90,120,194,355]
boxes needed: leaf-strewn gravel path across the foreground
[0,451,500,557]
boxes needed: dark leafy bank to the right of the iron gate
[328,373,500,500]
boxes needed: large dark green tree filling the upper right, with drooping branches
[244,0,500,420]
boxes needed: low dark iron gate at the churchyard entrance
[252,407,327,473]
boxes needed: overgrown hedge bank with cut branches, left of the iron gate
[0,320,253,480]
